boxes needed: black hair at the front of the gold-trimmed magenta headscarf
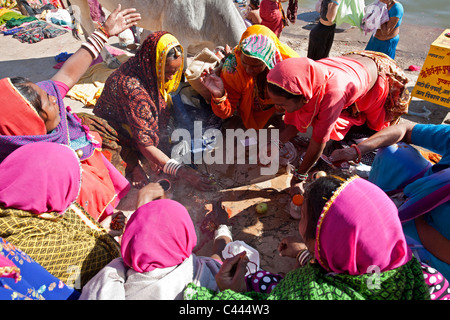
[305,171,351,239]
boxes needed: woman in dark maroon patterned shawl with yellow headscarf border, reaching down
[79,31,214,190]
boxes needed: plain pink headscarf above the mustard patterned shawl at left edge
[0,142,81,214]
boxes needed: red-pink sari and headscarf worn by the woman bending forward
[267,51,409,143]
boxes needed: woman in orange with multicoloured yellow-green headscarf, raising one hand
[201,25,299,129]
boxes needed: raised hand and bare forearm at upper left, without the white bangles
[52,4,141,89]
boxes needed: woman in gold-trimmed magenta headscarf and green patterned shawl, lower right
[188,175,436,300]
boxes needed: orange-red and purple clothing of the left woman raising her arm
[0,78,130,221]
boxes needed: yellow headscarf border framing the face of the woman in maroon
[156,33,184,105]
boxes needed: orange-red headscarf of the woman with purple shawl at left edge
[0,78,47,136]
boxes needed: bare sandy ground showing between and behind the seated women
[0,7,450,272]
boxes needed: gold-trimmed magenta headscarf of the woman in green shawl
[315,177,412,275]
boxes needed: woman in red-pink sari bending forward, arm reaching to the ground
[267,51,409,194]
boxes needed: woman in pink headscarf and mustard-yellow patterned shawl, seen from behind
[0,142,120,289]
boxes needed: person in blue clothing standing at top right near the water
[366,0,404,59]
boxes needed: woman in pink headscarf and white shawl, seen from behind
[80,195,232,300]
